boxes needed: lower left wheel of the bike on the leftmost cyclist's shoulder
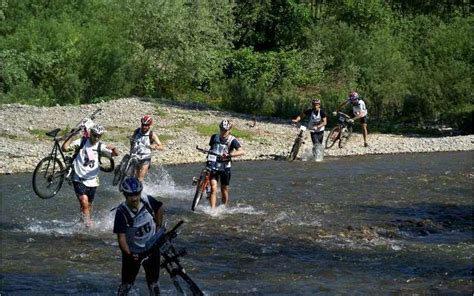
[33,155,64,199]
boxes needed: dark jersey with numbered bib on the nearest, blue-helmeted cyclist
[113,196,163,254]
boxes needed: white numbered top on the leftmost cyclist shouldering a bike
[71,139,112,187]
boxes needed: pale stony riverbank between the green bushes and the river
[0,98,474,174]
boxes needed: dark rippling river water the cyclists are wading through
[0,152,474,295]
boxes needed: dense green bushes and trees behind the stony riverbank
[0,0,474,132]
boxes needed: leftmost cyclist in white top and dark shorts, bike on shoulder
[62,124,119,227]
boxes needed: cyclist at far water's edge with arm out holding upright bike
[292,98,327,155]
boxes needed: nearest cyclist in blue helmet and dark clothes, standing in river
[113,176,163,295]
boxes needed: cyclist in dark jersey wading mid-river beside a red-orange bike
[208,119,245,208]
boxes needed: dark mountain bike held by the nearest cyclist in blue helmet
[147,220,204,296]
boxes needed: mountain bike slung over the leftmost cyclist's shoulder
[33,109,104,199]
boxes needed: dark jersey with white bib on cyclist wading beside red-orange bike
[208,134,240,171]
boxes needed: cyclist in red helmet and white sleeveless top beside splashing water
[130,115,164,181]
